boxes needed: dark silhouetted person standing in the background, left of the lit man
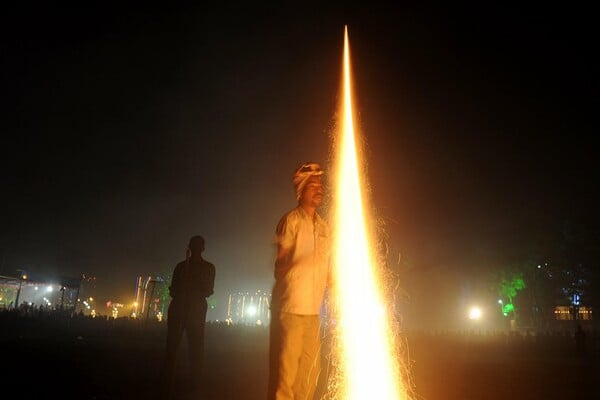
[163,236,215,399]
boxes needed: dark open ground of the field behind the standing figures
[0,314,600,400]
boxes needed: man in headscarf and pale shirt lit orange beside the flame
[269,163,330,400]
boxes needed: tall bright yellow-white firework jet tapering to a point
[331,26,408,400]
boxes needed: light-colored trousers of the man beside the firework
[275,313,321,400]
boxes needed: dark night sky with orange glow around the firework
[0,2,598,310]
